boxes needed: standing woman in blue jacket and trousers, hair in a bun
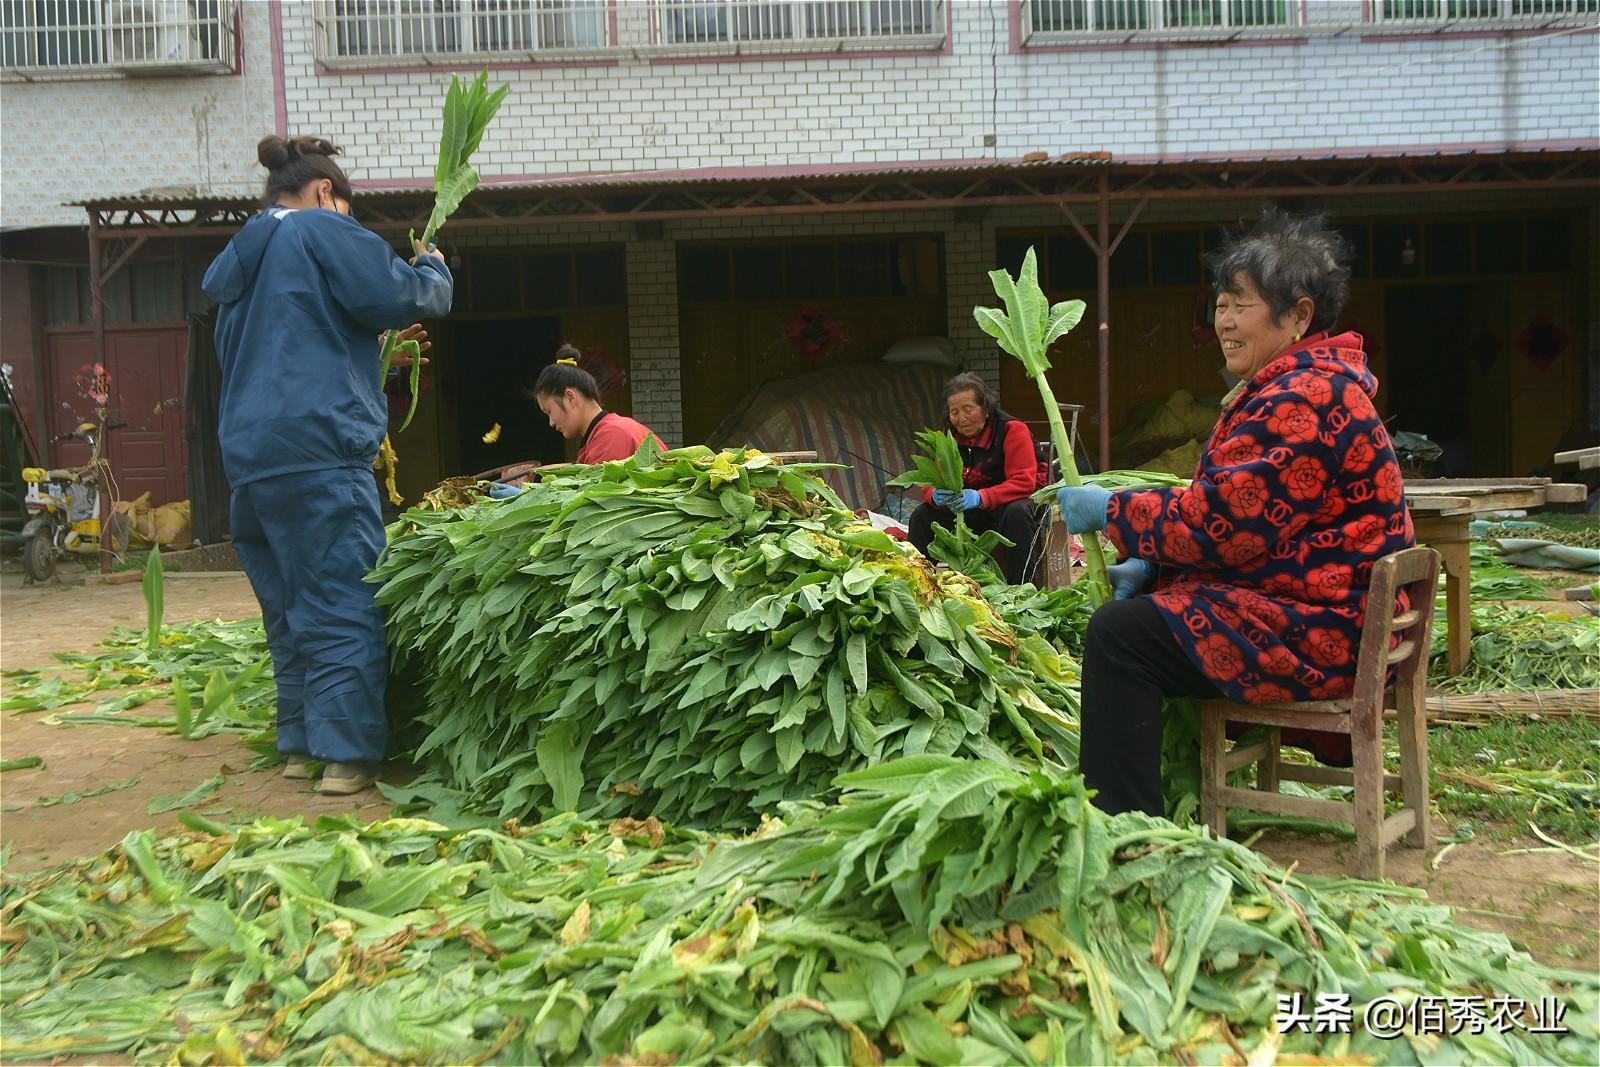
[205,138,453,793]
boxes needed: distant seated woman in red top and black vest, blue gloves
[909,373,1050,585]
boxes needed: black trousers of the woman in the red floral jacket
[1078,597,1219,816]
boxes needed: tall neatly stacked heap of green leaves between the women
[371,443,1077,827]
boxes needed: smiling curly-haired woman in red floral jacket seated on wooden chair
[1059,210,1414,814]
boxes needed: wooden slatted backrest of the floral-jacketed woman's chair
[1350,547,1438,717]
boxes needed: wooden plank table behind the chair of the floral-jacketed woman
[1405,478,1587,675]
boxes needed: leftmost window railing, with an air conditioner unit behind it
[0,0,238,78]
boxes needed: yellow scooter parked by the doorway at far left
[22,408,126,582]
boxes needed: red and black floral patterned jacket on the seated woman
[1106,333,1416,704]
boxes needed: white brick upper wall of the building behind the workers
[0,0,1600,229]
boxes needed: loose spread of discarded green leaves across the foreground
[0,755,1600,1064]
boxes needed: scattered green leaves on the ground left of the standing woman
[0,617,277,750]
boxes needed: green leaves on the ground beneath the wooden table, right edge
[1429,601,1600,693]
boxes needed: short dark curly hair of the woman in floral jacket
[1208,206,1350,333]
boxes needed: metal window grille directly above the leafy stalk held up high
[315,0,616,66]
